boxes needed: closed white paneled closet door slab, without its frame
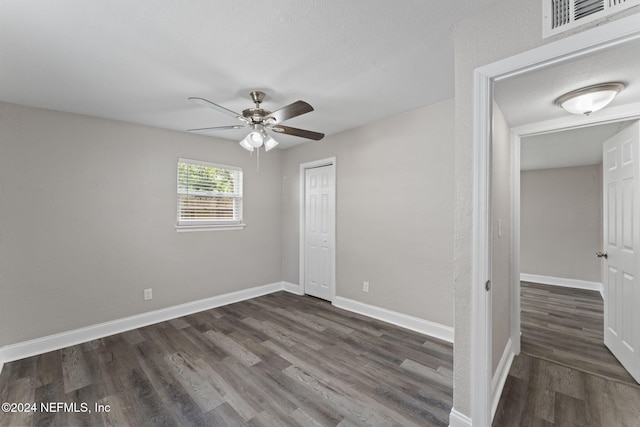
[304,165,335,301]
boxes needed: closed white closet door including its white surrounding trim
[300,158,336,301]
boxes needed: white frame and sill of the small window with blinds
[176,158,246,232]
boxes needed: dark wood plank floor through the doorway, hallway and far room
[493,282,640,427]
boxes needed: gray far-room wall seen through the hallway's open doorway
[520,165,602,282]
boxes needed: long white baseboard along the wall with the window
[0,282,286,366]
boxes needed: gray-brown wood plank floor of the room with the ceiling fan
[0,292,453,426]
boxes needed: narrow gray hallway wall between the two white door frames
[491,103,512,373]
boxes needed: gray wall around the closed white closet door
[283,100,454,326]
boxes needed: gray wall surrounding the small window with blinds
[0,104,282,346]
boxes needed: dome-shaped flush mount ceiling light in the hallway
[555,82,624,116]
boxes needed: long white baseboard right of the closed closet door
[333,296,453,343]
